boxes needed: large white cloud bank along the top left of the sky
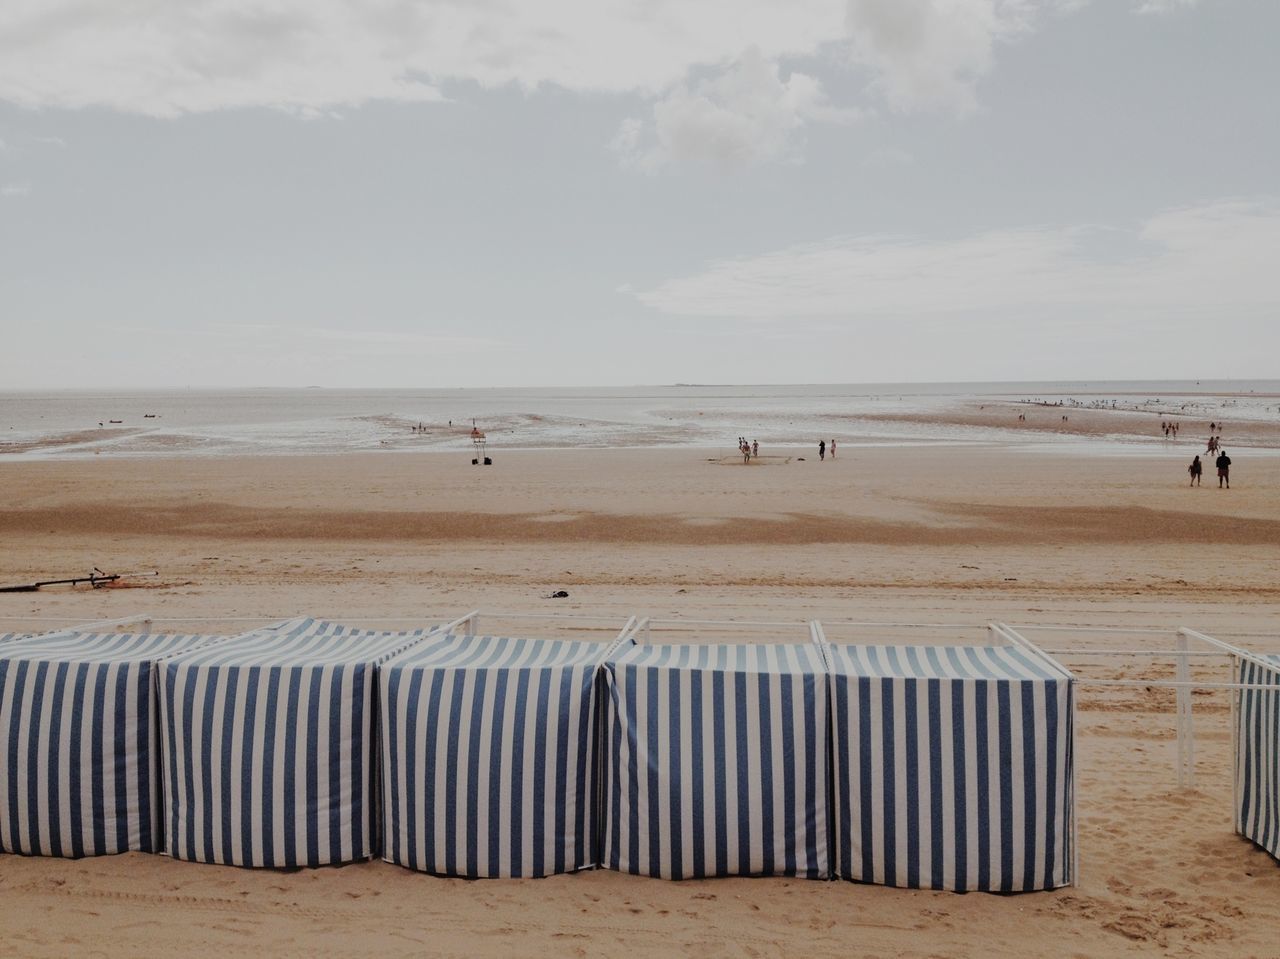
[0,0,842,117]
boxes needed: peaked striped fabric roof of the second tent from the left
[169,618,431,666]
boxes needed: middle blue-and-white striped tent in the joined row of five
[379,635,608,878]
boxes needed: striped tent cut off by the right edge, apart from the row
[1235,656,1280,859]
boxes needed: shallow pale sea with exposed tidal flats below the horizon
[0,380,1280,462]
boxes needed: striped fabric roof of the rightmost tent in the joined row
[829,645,1064,680]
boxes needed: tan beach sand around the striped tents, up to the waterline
[0,445,1280,956]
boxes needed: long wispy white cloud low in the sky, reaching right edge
[635,200,1280,320]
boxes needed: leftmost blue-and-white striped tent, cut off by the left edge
[0,633,220,858]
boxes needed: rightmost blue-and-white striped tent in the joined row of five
[827,645,1074,892]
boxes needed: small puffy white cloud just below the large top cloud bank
[611,47,856,173]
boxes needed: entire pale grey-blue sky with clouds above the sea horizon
[0,0,1280,389]
